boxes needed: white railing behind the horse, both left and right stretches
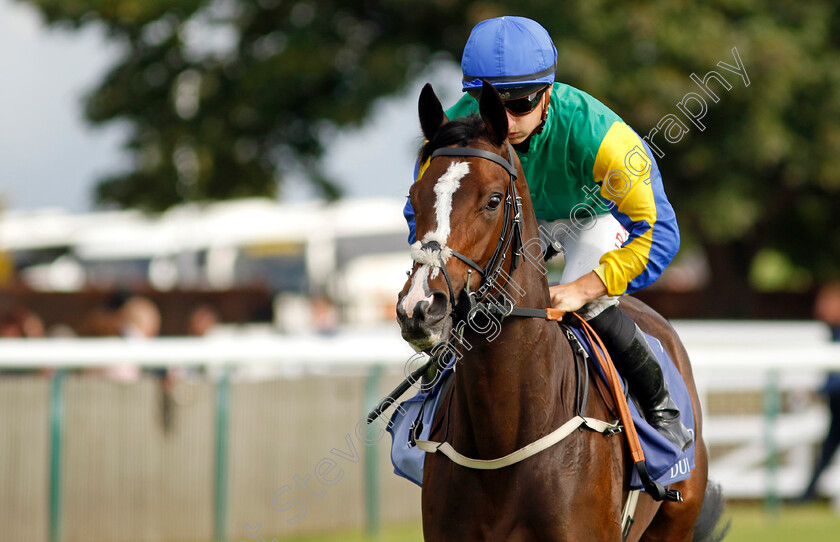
[0,321,840,507]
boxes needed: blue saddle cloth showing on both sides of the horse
[388,327,694,489]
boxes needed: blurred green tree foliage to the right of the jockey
[532,0,840,310]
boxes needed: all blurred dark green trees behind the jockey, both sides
[25,0,840,306]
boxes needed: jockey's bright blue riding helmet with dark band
[461,16,557,100]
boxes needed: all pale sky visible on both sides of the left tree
[0,0,460,213]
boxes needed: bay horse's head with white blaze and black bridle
[397,83,527,350]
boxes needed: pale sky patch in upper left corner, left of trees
[0,0,126,211]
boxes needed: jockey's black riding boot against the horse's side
[589,307,693,450]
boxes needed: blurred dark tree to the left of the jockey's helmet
[21,0,480,210]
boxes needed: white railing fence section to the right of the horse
[675,322,840,510]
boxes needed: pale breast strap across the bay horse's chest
[417,416,621,470]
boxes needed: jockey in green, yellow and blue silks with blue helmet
[404,17,693,449]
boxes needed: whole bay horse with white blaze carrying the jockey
[397,83,722,542]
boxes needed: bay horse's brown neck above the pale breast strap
[453,268,574,458]
